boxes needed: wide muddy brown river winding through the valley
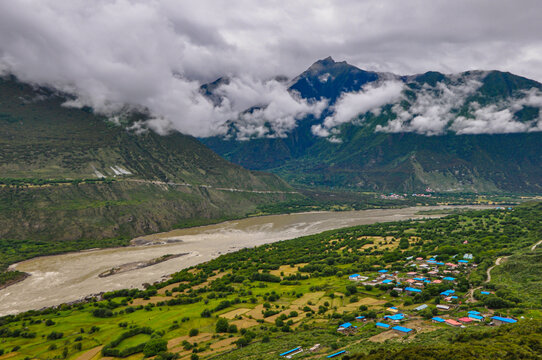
[0,206,488,316]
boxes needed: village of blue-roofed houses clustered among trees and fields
[279,254,517,359]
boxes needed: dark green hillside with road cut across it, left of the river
[0,78,300,267]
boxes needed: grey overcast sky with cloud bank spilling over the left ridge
[0,0,542,136]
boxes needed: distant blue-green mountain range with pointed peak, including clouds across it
[200,57,542,193]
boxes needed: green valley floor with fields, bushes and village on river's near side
[0,203,542,360]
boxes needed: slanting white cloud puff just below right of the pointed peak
[311,80,404,137]
